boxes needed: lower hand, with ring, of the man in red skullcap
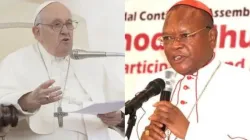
[141,122,166,140]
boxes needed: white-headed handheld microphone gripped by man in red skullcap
[160,71,174,132]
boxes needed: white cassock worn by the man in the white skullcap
[0,44,124,140]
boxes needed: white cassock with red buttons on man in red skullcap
[130,57,250,140]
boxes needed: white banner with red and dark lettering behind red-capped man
[125,0,250,140]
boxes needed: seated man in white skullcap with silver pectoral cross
[0,1,124,140]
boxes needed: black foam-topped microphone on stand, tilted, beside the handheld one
[125,78,165,115]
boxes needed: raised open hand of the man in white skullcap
[18,80,62,112]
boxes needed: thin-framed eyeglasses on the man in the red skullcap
[157,26,212,46]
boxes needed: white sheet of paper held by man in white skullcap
[69,101,125,115]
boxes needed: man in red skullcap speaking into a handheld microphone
[133,0,250,140]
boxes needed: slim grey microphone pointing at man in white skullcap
[70,49,125,60]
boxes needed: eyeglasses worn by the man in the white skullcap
[37,21,78,32]
